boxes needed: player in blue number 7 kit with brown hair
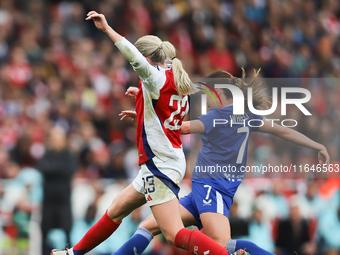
[118,71,329,255]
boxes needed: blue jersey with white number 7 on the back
[191,105,263,197]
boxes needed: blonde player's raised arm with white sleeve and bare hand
[86,11,165,92]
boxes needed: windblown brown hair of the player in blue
[204,68,269,110]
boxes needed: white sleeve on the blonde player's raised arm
[115,37,166,94]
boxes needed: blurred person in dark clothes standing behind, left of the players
[37,127,77,254]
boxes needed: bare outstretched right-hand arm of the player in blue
[259,118,330,164]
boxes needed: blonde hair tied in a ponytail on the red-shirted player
[135,35,193,95]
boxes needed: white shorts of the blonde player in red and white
[132,157,186,206]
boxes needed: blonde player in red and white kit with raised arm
[51,11,235,255]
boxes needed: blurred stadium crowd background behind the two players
[0,0,340,255]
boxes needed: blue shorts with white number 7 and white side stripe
[179,182,233,229]
